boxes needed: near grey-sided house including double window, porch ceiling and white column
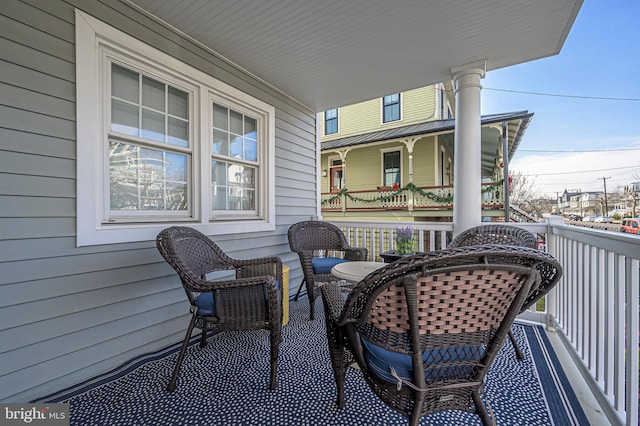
[0,0,582,402]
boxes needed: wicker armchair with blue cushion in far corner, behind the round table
[288,220,368,319]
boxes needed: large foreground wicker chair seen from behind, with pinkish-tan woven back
[322,245,562,425]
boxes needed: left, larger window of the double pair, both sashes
[105,62,193,221]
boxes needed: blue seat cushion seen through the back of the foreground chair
[360,339,484,383]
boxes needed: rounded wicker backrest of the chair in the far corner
[287,220,349,253]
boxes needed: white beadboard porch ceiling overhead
[124,0,582,111]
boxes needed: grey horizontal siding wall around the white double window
[0,0,317,402]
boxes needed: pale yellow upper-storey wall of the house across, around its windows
[322,86,436,141]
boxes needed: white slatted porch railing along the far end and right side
[333,218,640,425]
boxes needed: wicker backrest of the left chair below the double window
[156,226,235,291]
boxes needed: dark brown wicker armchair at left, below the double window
[156,227,283,392]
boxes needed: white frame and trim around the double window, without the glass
[75,10,275,247]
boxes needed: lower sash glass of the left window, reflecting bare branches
[109,141,188,211]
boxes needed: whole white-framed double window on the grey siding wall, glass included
[76,11,275,246]
